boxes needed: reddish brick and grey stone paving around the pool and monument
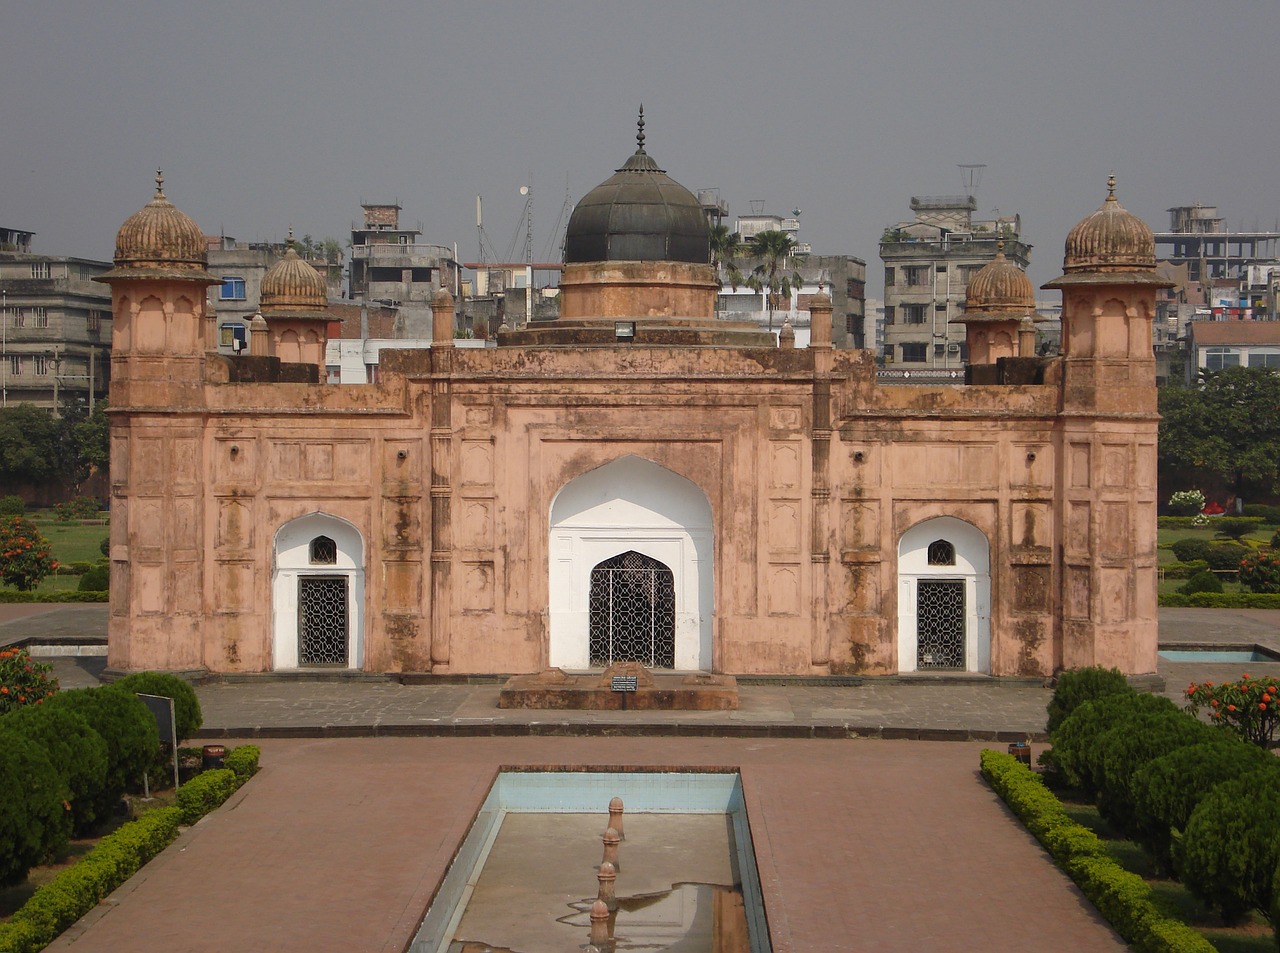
[0,606,1280,953]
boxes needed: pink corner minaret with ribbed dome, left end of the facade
[96,170,218,670]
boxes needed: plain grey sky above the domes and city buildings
[0,0,1280,294]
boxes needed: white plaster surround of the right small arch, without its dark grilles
[897,517,991,672]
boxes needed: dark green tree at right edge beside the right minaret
[1160,367,1280,500]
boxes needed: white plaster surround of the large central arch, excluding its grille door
[548,454,714,670]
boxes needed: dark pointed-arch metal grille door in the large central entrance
[589,551,676,669]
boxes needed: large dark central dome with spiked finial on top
[564,109,710,265]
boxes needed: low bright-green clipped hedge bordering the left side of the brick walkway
[0,744,260,953]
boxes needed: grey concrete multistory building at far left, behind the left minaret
[0,229,111,413]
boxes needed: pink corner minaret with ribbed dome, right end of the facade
[1044,177,1169,672]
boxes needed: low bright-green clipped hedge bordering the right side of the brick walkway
[979,748,1215,953]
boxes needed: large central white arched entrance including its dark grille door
[548,457,714,670]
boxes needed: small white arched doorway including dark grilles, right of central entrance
[897,517,991,672]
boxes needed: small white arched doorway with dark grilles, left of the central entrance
[271,513,365,669]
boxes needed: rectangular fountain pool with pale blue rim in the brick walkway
[410,769,769,953]
